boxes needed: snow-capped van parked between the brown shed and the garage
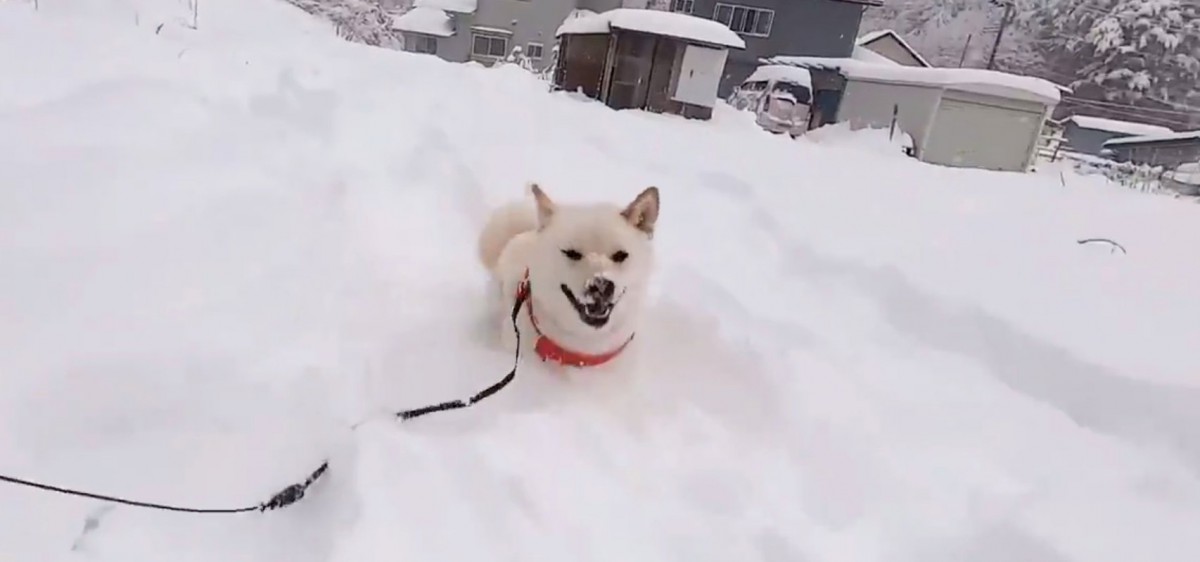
[728,65,812,138]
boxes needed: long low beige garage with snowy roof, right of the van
[764,56,1061,172]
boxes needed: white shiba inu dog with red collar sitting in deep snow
[479,184,659,367]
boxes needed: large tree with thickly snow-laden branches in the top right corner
[1045,0,1200,107]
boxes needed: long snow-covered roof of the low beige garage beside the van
[764,56,1062,104]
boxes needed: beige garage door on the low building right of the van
[922,97,1042,172]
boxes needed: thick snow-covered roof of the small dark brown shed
[554,8,746,49]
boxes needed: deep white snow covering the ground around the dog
[0,0,1200,562]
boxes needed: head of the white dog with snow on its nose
[529,185,659,330]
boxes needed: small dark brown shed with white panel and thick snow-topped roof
[553,8,745,119]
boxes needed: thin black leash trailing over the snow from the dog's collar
[0,289,529,514]
